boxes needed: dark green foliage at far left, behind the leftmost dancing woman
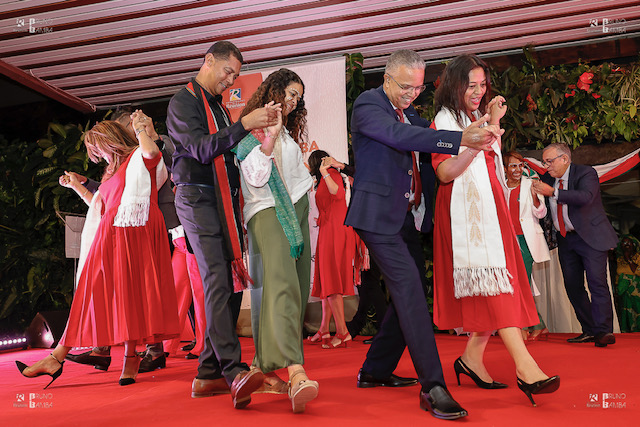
[0,123,100,330]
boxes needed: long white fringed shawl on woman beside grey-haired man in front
[434,109,513,298]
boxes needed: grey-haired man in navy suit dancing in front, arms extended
[345,50,502,419]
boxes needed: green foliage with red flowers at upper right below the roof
[491,49,640,151]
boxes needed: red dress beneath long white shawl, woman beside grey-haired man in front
[431,151,538,332]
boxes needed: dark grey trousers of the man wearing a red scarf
[175,185,249,384]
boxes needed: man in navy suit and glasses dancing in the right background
[534,144,618,347]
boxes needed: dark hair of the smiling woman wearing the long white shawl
[435,55,491,127]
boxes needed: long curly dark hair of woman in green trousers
[240,68,307,144]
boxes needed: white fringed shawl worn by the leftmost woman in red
[76,147,169,286]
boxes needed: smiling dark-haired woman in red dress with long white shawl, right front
[432,55,560,405]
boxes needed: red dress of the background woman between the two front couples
[311,168,356,298]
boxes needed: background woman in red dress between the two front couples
[309,150,356,348]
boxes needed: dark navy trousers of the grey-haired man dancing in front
[356,212,446,390]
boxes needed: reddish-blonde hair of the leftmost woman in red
[84,120,138,182]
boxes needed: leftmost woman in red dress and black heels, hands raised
[16,115,180,388]
